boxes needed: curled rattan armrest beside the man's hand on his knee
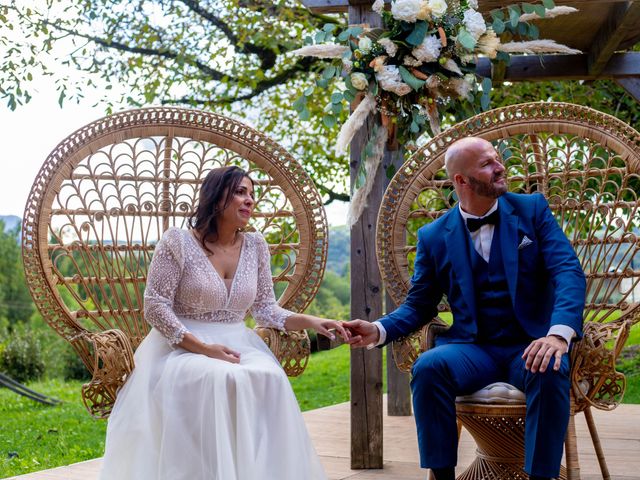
[571,320,631,411]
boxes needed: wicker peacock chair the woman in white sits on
[22,108,328,418]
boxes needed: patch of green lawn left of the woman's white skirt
[0,380,106,478]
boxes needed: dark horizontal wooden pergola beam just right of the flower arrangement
[476,52,640,82]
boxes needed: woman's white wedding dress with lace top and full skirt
[101,228,326,480]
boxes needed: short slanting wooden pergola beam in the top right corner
[588,1,640,76]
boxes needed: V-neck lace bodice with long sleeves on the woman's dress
[144,228,293,344]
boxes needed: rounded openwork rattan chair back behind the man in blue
[376,103,640,406]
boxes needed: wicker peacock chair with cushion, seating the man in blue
[377,103,640,480]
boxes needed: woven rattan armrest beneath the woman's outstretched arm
[254,327,311,377]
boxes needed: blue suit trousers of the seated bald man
[411,343,570,477]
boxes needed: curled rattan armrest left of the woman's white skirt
[82,330,134,418]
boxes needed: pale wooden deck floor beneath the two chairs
[6,403,640,480]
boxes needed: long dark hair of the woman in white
[189,166,255,253]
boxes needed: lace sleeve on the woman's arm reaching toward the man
[251,234,293,330]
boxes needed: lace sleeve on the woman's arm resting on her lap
[144,229,188,345]
